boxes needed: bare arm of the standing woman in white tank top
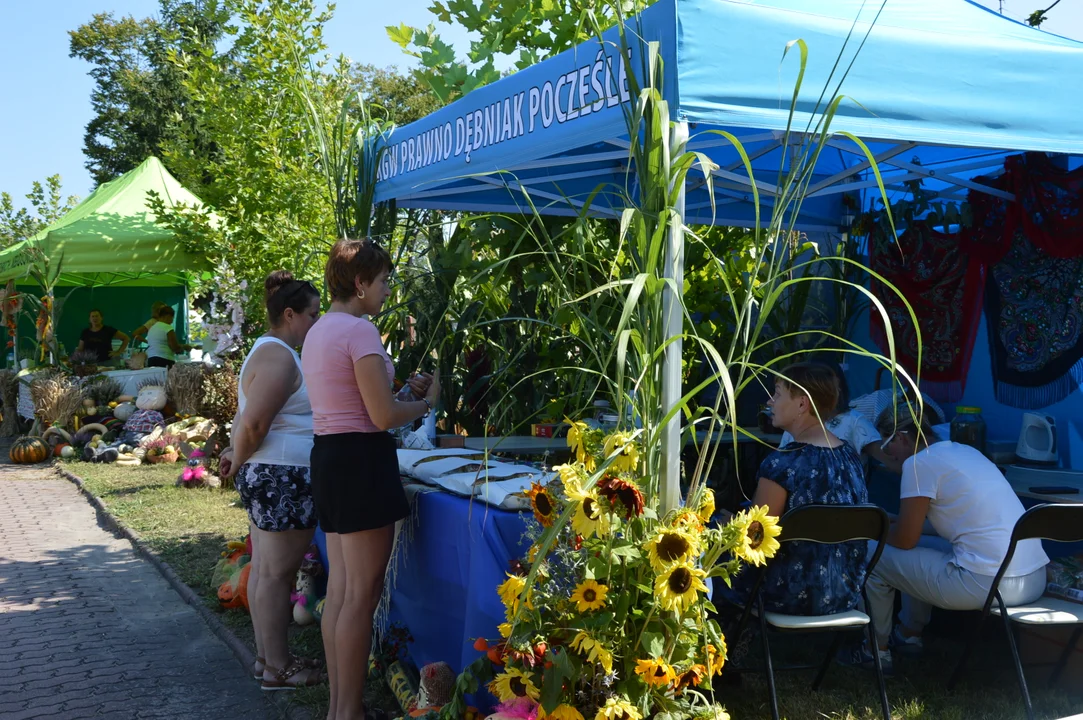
[230,345,299,474]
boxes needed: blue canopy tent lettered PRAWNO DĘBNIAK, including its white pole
[375,0,1083,507]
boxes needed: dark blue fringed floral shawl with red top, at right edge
[969,154,1083,409]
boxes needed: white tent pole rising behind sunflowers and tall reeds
[662,122,688,513]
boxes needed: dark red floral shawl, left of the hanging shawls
[870,222,983,403]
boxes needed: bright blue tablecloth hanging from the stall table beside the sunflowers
[316,493,529,673]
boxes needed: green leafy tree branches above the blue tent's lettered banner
[387,0,651,103]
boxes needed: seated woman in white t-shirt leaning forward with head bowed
[866,405,1049,667]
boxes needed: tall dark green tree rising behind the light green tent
[68,0,227,183]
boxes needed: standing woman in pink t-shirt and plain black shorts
[301,240,440,720]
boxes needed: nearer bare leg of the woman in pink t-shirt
[335,525,395,720]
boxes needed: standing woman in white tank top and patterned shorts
[222,271,322,690]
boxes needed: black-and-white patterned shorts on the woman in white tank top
[234,462,316,533]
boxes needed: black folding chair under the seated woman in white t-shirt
[948,505,1083,720]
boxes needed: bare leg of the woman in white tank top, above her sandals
[250,529,314,681]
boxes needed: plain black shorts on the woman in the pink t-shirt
[312,432,409,535]
